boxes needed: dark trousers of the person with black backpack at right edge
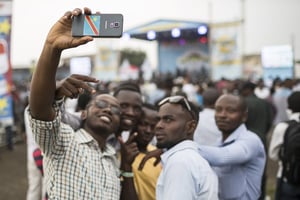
[275,178,300,200]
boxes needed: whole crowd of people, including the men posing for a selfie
[6,8,300,200]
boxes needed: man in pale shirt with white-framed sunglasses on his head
[155,96,218,200]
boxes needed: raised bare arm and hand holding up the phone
[29,8,93,121]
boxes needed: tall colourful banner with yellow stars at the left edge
[0,1,13,126]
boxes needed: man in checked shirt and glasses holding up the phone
[28,8,138,200]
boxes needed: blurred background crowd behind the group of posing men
[5,69,300,199]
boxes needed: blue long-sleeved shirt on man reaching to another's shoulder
[199,124,266,200]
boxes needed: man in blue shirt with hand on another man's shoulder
[199,94,266,200]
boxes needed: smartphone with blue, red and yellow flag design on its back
[72,14,123,38]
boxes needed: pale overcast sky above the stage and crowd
[11,0,300,66]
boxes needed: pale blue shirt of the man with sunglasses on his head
[156,140,218,200]
